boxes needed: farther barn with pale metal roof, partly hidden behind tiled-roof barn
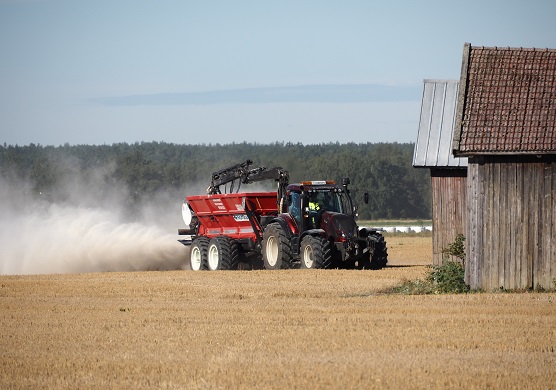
[413,80,467,265]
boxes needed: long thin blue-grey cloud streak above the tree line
[85,84,421,106]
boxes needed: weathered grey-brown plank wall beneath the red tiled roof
[465,155,556,291]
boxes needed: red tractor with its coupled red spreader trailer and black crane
[178,160,388,270]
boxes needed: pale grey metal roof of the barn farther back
[413,80,467,168]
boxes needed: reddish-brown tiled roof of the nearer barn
[453,43,556,156]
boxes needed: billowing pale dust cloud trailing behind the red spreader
[0,175,187,275]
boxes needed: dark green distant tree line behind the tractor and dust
[0,142,431,219]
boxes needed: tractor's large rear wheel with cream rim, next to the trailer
[263,222,292,269]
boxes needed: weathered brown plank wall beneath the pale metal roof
[431,168,467,265]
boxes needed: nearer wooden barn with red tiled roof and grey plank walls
[453,44,556,291]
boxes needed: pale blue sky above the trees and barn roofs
[0,0,556,145]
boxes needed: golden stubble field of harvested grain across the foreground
[0,237,556,389]
